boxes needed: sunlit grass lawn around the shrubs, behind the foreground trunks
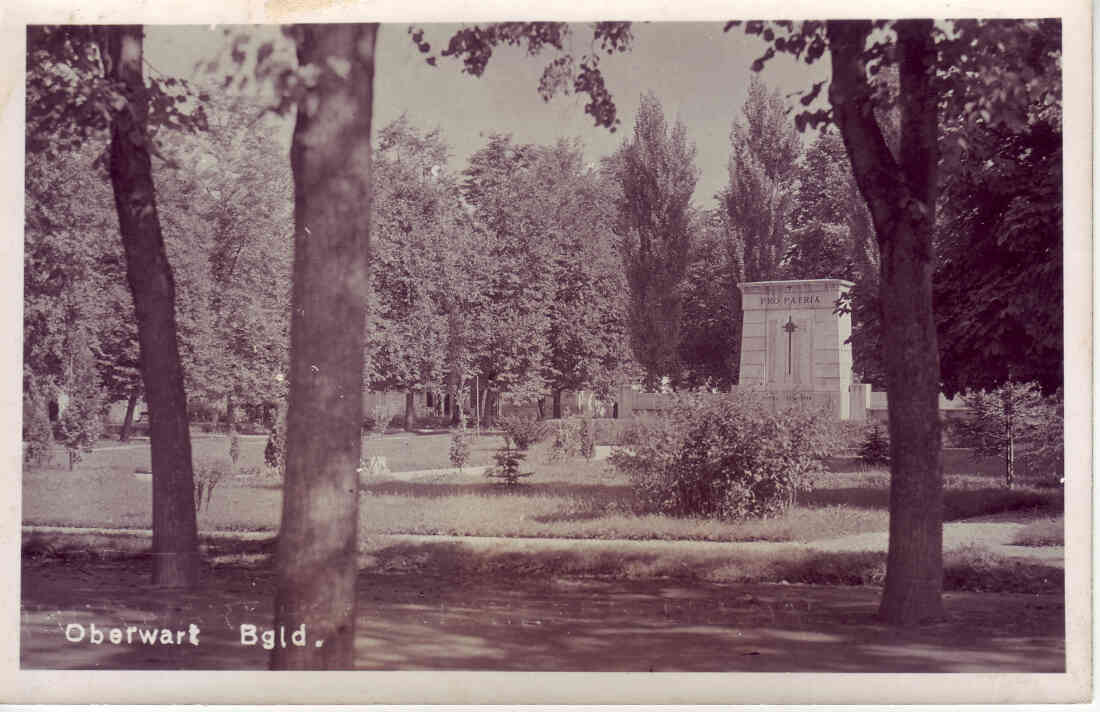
[23,435,1062,541]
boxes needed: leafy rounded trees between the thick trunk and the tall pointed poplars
[366,118,628,419]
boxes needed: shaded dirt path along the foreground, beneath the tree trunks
[21,558,1065,672]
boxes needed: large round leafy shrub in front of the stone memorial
[612,393,831,519]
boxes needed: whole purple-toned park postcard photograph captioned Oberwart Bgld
[6,0,1092,702]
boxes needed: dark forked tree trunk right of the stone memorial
[827,20,943,625]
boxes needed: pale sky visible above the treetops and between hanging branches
[145,22,828,208]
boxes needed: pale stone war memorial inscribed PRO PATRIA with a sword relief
[738,280,870,420]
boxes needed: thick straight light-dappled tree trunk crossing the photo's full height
[271,24,377,669]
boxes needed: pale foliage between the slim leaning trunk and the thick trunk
[158,98,292,422]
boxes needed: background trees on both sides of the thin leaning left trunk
[23,86,290,439]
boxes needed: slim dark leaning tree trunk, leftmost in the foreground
[103,25,198,585]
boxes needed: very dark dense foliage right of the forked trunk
[935,21,1065,394]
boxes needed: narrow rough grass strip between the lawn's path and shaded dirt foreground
[22,530,1065,593]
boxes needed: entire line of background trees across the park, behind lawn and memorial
[32,45,1062,437]
